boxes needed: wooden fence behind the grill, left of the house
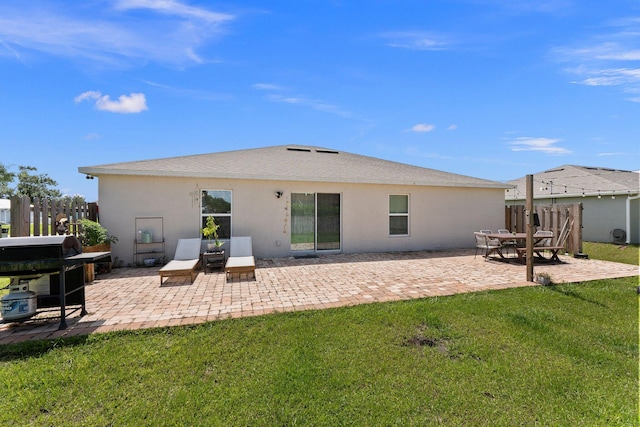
[11,196,98,237]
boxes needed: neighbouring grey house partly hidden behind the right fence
[505,165,640,243]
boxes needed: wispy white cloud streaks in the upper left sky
[0,0,235,67]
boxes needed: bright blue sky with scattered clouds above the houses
[0,0,640,200]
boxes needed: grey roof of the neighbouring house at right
[505,165,640,200]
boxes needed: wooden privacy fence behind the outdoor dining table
[504,203,582,254]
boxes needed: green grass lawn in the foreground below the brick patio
[0,242,639,426]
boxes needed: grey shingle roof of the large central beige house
[78,145,511,189]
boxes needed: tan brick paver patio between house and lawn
[0,250,639,344]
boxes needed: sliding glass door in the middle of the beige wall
[291,193,341,251]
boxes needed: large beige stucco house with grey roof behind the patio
[78,146,509,263]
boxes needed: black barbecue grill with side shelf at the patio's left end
[0,235,111,329]
